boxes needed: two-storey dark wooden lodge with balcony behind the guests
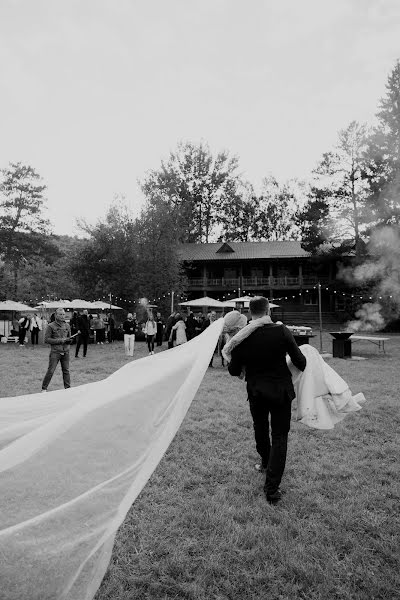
[179,241,344,324]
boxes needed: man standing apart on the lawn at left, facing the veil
[42,308,71,392]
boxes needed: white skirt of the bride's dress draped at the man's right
[288,344,365,429]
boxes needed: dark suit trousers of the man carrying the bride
[249,391,292,494]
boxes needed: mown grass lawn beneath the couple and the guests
[0,333,400,600]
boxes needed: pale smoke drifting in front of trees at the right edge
[339,226,400,330]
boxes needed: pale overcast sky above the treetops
[0,0,400,234]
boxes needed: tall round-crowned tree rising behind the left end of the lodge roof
[141,142,239,242]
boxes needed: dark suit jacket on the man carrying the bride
[228,323,306,400]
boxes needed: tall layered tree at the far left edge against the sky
[0,162,57,295]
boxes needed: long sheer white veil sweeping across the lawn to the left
[0,319,223,600]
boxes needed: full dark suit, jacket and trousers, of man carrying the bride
[228,323,306,495]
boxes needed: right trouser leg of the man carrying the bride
[264,394,292,498]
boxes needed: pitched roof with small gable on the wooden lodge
[179,241,310,261]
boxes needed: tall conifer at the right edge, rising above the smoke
[363,60,400,225]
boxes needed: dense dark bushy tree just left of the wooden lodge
[71,199,184,308]
